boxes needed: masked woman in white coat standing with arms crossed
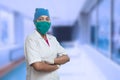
[25,8,69,80]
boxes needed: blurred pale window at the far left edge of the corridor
[0,9,14,47]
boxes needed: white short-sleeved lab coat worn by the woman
[25,30,66,80]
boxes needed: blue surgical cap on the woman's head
[33,8,49,22]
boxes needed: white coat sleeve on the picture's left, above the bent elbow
[25,38,42,65]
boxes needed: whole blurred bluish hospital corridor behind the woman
[0,0,120,80]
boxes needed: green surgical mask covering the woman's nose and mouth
[35,21,51,35]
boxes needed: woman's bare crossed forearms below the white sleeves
[31,55,70,72]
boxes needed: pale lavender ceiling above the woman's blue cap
[0,0,86,24]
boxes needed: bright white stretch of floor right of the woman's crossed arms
[59,46,107,80]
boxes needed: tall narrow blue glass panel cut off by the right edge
[112,0,120,64]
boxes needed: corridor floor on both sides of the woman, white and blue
[0,42,107,80]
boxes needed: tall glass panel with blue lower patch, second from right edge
[97,0,111,56]
